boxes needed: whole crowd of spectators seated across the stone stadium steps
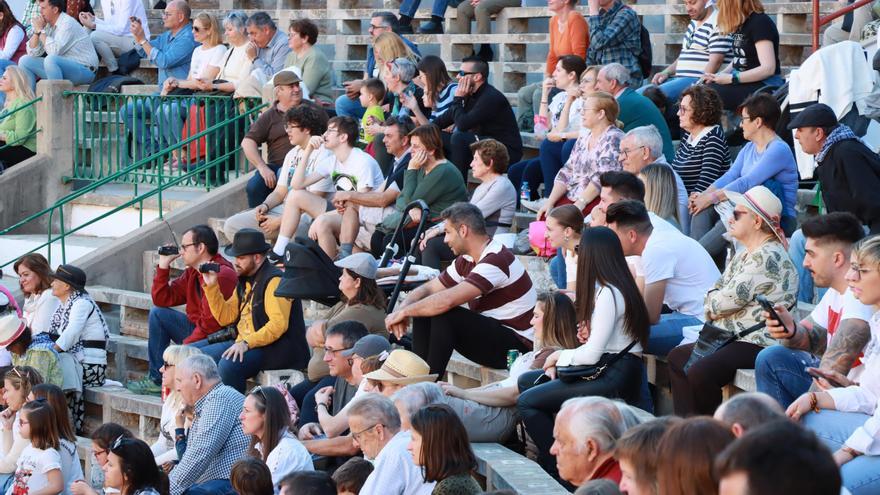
[8,0,880,495]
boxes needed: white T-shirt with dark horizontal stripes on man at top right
[675,9,733,77]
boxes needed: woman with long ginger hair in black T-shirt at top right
[702,0,785,110]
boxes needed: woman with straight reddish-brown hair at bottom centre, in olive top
[407,404,483,495]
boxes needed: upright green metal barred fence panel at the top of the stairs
[64,91,263,187]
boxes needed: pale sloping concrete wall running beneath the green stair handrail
[71,174,250,292]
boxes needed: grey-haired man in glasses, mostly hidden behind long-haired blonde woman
[618,124,691,235]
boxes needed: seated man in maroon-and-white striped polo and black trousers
[385,203,537,376]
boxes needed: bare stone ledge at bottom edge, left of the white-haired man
[471,443,569,495]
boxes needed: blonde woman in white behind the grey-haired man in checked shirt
[150,345,202,466]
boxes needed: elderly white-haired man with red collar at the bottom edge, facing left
[545,397,652,487]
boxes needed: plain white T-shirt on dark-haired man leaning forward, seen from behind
[642,219,721,320]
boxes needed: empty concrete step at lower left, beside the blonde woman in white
[84,385,162,441]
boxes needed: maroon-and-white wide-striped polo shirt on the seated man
[440,240,537,340]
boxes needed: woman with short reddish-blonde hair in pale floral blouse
[538,91,624,220]
